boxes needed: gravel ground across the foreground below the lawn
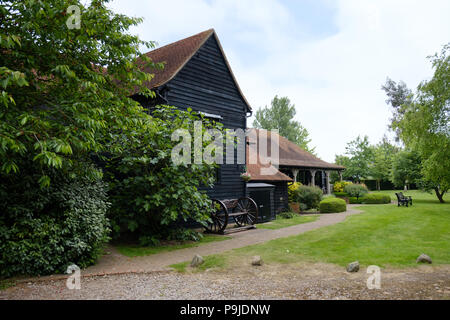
[0,264,450,300]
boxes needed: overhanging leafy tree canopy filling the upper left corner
[0,0,161,187]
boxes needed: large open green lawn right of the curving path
[171,191,450,270]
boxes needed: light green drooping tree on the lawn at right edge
[384,43,450,202]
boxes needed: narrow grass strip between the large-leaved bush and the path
[115,234,231,257]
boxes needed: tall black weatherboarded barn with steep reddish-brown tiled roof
[138,29,251,199]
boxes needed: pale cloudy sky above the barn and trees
[110,0,450,162]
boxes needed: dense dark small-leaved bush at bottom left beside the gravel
[0,170,109,277]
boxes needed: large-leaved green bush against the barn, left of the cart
[105,106,220,244]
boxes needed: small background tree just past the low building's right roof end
[336,136,374,182]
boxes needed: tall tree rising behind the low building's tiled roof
[253,96,315,153]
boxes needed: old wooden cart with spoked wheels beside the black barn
[205,197,258,234]
